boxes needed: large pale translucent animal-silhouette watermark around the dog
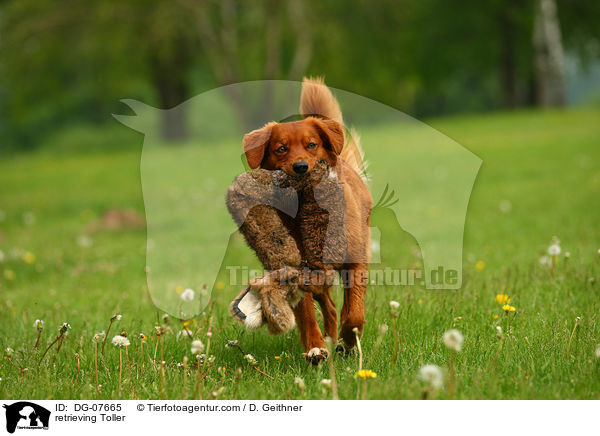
[115,81,481,318]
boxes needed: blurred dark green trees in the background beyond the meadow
[0,0,600,151]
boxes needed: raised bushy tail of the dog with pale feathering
[300,77,367,180]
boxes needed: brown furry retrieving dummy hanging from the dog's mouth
[227,162,347,334]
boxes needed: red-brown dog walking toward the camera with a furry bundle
[239,79,373,363]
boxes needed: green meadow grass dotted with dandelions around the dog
[0,109,600,399]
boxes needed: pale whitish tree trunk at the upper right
[533,0,566,107]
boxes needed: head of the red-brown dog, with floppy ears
[244,117,344,175]
